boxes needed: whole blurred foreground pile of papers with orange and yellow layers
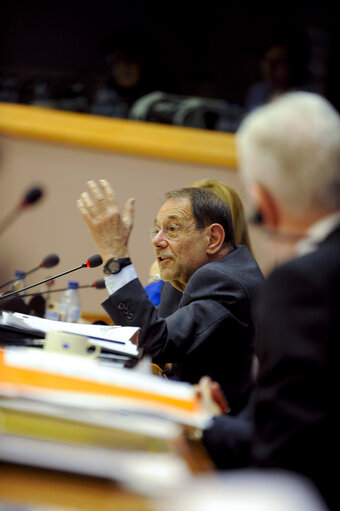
[0,347,209,492]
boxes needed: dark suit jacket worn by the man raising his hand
[103,246,264,413]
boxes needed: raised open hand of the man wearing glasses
[77,179,135,263]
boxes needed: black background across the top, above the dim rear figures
[0,0,339,112]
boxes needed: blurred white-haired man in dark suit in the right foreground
[201,92,340,510]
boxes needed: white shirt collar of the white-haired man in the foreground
[295,211,340,255]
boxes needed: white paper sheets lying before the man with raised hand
[1,311,140,357]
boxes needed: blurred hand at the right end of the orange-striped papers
[194,376,229,415]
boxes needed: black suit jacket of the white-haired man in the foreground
[201,229,340,509]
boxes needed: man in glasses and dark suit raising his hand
[78,184,263,413]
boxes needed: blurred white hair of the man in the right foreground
[236,92,340,216]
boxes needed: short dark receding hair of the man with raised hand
[165,187,235,247]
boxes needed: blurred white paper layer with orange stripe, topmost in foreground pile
[0,347,205,427]
